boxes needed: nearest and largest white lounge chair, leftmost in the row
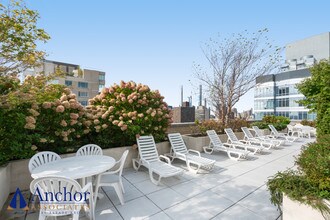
[133,136,183,185]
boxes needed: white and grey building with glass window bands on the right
[254,32,330,120]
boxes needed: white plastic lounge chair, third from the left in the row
[204,130,250,160]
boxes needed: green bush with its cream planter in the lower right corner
[267,135,330,219]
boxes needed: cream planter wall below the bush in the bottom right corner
[282,195,325,220]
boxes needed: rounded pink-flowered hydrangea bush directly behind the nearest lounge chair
[84,81,172,147]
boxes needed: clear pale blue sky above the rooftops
[26,0,330,111]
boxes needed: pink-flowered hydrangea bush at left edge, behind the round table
[0,75,84,164]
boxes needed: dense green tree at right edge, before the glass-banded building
[297,60,330,136]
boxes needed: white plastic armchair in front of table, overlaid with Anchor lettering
[30,176,95,220]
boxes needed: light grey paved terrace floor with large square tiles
[0,139,314,220]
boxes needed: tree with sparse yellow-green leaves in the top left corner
[0,0,50,75]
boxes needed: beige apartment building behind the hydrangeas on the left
[23,60,105,106]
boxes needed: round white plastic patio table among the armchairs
[31,155,116,203]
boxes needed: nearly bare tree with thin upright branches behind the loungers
[194,29,280,124]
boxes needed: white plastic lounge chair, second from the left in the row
[168,133,215,173]
